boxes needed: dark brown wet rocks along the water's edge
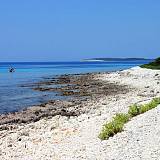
[0,69,131,130]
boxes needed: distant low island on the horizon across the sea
[82,58,153,62]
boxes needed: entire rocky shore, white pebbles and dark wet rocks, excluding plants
[0,67,160,160]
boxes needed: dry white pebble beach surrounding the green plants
[0,67,160,160]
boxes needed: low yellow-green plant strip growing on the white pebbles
[99,98,160,140]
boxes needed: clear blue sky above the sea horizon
[0,0,160,62]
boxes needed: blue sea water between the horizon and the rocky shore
[0,60,150,113]
